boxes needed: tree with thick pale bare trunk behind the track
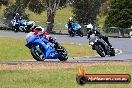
[29,0,67,33]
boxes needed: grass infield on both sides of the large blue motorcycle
[0,37,96,61]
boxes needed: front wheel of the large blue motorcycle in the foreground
[30,46,45,61]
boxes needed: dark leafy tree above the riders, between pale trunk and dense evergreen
[73,0,100,24]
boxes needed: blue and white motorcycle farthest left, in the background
[11,19,35,33]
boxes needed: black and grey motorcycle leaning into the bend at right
[89,33,115,57]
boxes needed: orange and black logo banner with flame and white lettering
[76,67,131,85]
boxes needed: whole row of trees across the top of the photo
[0,0,132,32]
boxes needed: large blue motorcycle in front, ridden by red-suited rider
[25,32,68,61]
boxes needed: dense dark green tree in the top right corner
[104,0,132,28]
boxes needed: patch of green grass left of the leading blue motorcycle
[0,38,32,61]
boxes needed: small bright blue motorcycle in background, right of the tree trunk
[65,23,83,37]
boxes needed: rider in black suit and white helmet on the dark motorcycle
[87,23,112,47]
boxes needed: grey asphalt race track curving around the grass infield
[0,31,132,64]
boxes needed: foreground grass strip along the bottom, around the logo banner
[0,64,132,88]
